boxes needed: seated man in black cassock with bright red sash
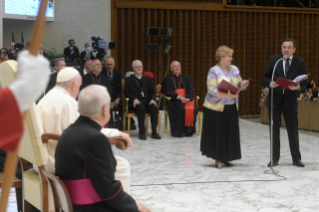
[161,60,197,137]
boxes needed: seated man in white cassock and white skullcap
[37,67,132,194]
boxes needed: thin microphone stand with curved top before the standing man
[264,56,287,174]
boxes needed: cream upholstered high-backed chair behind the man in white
[0,60,49,212]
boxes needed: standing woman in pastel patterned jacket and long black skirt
[200,46,249,168]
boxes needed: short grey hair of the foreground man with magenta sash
[78,85,111,117]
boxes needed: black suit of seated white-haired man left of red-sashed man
[124,75,158,134]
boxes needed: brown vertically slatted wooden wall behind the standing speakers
[113,3,319,116]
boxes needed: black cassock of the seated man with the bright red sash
[161,74,197,137]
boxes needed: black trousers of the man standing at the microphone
[268,101,301,162]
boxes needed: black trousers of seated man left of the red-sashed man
[133,100,158,134]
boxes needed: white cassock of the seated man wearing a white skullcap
[37,86,131,194]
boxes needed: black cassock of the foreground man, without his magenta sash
[55,116,138,212]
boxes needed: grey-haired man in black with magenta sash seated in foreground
[55,85,150,212]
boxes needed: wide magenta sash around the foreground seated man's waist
[61,179,103,205]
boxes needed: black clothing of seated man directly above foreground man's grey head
[81,73,113,96]
